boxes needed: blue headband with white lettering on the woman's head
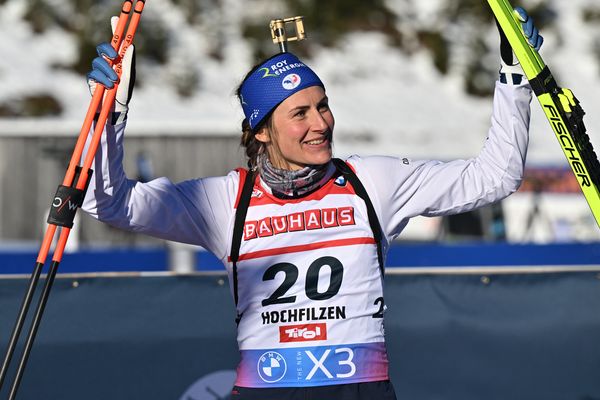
[240,53,325,129]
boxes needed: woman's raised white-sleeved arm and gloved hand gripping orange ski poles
[82,18,238,257]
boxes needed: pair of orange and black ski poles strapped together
[0,0,144,399]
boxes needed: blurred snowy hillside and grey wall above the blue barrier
[0,0,600,272]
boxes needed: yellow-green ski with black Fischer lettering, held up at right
[488,0,600,226]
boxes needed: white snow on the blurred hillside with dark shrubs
[0,0,600,164]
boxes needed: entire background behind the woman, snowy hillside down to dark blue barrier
[0,0,600,400]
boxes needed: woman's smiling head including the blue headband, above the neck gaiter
[237,53,334,170]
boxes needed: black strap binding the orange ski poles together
[47,167,93,229]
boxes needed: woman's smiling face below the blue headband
[256,86,335,170]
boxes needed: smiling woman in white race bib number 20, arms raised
[83,10,542,400]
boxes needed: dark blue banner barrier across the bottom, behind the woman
[0,271,600,400]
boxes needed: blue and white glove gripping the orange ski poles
[86,17,135,117]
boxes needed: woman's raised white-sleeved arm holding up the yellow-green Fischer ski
[350,10,542,238]
